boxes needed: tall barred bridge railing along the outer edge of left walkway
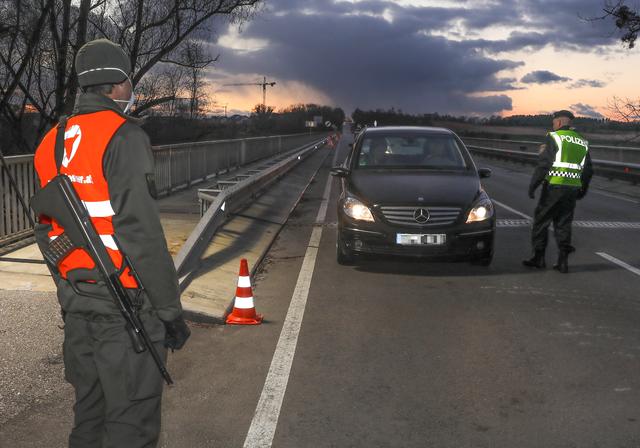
[0,134,325,245]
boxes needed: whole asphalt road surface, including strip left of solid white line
[0,130,640,448]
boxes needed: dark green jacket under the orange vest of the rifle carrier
[35,93,182,321]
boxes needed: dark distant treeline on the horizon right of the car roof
[352,108,640,132]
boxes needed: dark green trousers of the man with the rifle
[64,312,167,448]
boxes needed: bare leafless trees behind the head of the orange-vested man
[0,0,261,152]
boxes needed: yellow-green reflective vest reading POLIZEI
[547,130,589,187]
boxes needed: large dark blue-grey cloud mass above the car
[220,3,521,114]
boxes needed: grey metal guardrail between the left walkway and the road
[175,137,329,288]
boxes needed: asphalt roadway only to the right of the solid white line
[266,131,640,447]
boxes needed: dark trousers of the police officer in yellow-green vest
[531,184,580,253]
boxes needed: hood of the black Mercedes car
[347,170,480,207]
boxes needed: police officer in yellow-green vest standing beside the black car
[522,110,593,274]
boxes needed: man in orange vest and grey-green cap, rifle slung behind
[35,39,190,448]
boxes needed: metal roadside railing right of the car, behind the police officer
[462,138,640,184]
